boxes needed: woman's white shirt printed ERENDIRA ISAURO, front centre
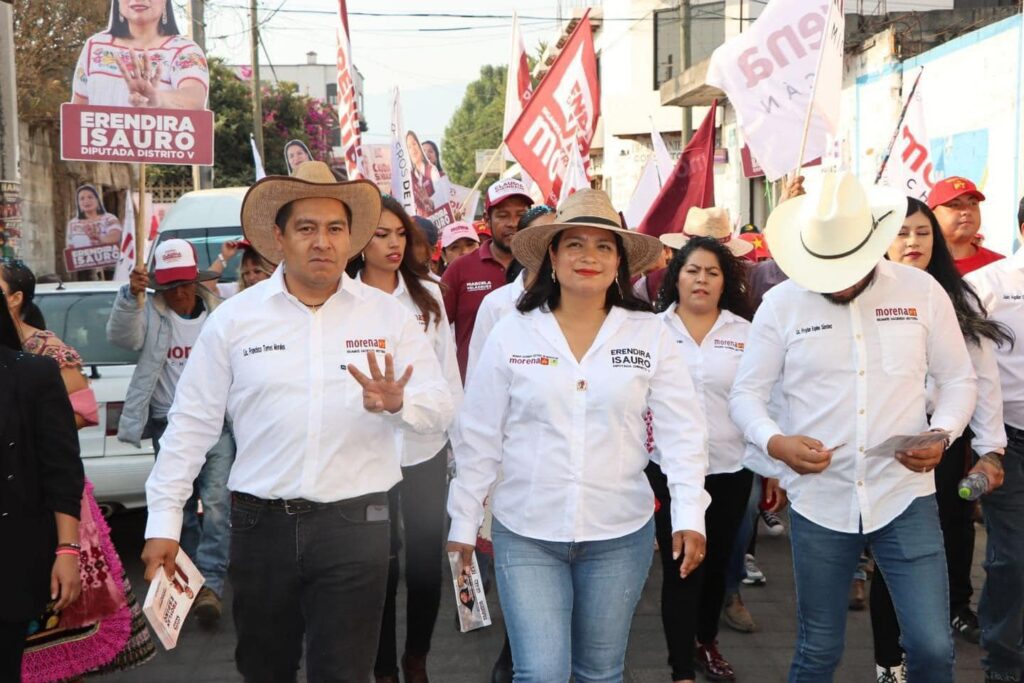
[449,307,710,544]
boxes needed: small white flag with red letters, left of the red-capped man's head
[881,73,935,202]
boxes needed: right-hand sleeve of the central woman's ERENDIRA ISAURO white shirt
[647,326,711,537]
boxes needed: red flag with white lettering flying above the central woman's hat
[505,10,601,206]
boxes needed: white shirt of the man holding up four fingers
[145,266,454,539]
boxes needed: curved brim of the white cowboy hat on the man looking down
[764,186,907,294]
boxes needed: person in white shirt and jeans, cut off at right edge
[965,206,1024,681]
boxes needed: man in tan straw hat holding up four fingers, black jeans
[142,162,453,681]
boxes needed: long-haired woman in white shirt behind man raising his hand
[348,195,462,683]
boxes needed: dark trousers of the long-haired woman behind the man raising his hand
[374,447,447,676]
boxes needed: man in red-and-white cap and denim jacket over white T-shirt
[106,240,234,626]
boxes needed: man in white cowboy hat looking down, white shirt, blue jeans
[730,173,976,683]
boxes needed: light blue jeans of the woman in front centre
[492,516,654,683]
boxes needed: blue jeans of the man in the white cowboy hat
[790,496,954,683]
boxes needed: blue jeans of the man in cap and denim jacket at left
[150,418,234,596]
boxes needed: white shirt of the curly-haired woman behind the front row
[651,306,751,474]
